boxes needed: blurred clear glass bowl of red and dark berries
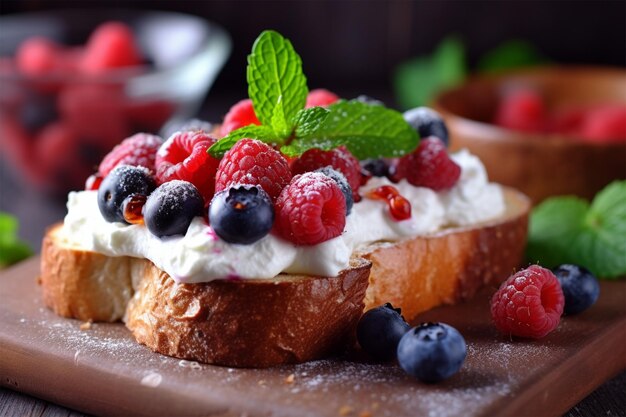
[0,10,230,193]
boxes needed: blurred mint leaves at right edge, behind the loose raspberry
[526,181,626,278]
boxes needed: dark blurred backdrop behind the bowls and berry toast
[0,0,626,250]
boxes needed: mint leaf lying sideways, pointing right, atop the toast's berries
[281,100,419,159]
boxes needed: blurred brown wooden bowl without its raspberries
[434,67,626,204]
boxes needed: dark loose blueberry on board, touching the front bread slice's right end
[356,303,410,361]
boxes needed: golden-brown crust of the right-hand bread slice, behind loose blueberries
[362,188,530,320]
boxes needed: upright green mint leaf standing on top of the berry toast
[247,30,309,128]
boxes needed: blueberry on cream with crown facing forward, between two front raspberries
[209,184,274,245]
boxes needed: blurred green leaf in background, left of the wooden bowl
[393,37,466,109]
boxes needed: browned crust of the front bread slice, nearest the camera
[126,260,370,367]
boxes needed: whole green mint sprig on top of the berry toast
[209,31,419,159]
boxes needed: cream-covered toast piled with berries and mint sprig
[41,31,530,367]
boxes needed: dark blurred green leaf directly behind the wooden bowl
[478,40,547,72]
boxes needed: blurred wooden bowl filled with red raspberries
[435,67,626,204]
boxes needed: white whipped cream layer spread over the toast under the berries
[63,150,505,283]
